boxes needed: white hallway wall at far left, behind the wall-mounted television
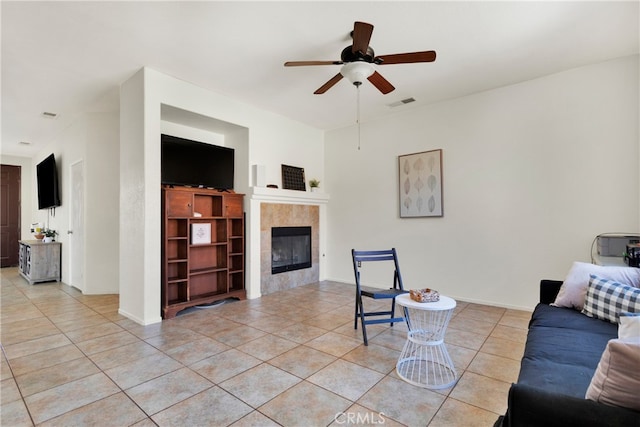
[8,113,119,294]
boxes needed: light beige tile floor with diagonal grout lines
[0,268,530,427]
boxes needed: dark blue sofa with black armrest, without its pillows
[495,280,640,427]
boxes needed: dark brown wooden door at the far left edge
[0,165,21,267]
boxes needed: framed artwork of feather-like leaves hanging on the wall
[398,150,443,218]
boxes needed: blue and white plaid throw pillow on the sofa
[582,275,640,323]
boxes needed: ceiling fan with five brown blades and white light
[284,21,436,95]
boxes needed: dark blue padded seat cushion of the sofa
[518,304,618,399]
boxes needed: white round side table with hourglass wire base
[396,294,458,389]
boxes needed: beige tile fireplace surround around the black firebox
[260,203,320,295]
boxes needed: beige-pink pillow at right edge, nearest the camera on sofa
[586,337,640,411]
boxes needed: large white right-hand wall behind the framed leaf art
[325,56,640,309]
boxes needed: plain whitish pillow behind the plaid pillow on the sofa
[552,262,640,310]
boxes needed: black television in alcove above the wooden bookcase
[160,134,235,190]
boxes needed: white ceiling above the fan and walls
[1,1,640,157]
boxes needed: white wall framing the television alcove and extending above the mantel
[120,68,324,324]
